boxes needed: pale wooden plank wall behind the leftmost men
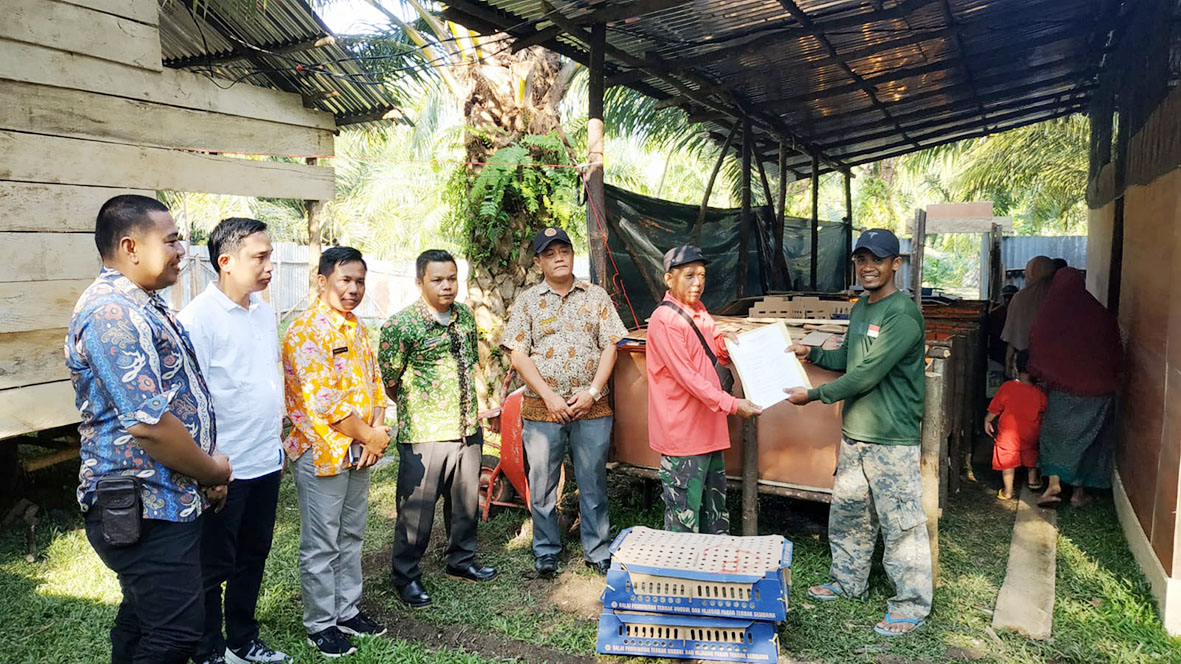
[0,0,335,440]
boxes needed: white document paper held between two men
[726,323,811,409]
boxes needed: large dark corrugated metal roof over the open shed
[443,0,1120,175]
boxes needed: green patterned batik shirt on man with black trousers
[377,300,479,443]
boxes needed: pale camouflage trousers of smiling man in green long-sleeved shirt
[828,440,932,619]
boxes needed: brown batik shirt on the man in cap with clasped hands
[501,281,627,422]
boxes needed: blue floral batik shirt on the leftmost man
[65,267,216,521]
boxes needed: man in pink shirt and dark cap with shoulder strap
[646,245,762,535]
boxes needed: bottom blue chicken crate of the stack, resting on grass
[595,610,779,663]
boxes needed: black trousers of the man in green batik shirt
[392,441,483,586]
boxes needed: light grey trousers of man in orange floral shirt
[295,450,370,634]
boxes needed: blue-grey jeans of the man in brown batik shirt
[521,416,614,562]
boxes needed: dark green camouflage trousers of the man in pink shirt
[660,451,730,535]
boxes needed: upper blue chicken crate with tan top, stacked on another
[602,526,791,621]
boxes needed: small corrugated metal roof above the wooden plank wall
[159,0,402,126]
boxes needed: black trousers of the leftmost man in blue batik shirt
[86,510,204,664]
